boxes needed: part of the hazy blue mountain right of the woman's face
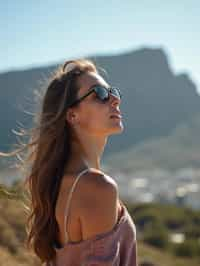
[92,49,200,156]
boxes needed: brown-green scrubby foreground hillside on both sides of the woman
[0,183,200,266]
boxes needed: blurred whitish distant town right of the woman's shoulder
[107,168,200,209]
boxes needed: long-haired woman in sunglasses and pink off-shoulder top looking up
[0,59,137,266]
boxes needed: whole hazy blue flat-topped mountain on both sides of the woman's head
[0,48,200,160]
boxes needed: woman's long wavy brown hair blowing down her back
[0,59,97,262]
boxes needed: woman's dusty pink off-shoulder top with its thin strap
[45,168,138,266]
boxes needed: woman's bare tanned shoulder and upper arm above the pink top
[79,171,118,240]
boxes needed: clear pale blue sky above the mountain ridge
[0,0,200,91]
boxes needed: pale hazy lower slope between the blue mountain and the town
[105,111,200,172]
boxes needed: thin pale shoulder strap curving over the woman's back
[64,168,90,243]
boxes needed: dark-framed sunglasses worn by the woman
[68,85,122,107]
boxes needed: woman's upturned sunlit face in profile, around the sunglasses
[67,72,123,137]
